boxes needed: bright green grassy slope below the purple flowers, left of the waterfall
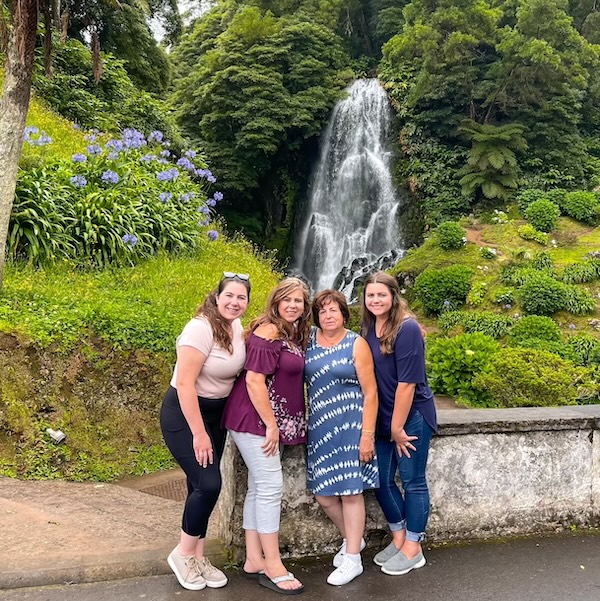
[0,237,278,352]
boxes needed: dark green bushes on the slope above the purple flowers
[34,40,181,144]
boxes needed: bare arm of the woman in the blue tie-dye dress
[353,338,379,462]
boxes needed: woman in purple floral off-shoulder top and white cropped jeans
[223,278,310,595]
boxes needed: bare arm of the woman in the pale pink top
[175,346,214,467]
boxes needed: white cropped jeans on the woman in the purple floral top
[229,430,283,534]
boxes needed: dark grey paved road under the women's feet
[0,534,600,601]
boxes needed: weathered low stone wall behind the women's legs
[220,405,600,556]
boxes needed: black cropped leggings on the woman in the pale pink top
[160,386,227,538]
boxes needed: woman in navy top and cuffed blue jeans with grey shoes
[362,272,437,575]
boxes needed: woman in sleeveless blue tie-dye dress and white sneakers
[304,290,379,585]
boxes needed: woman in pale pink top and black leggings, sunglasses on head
[160,272,250,590]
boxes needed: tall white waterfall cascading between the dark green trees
[295,79,402,300]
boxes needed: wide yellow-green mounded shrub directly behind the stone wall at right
[473,347,597,407]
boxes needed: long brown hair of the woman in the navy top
[360,271,411,355]
